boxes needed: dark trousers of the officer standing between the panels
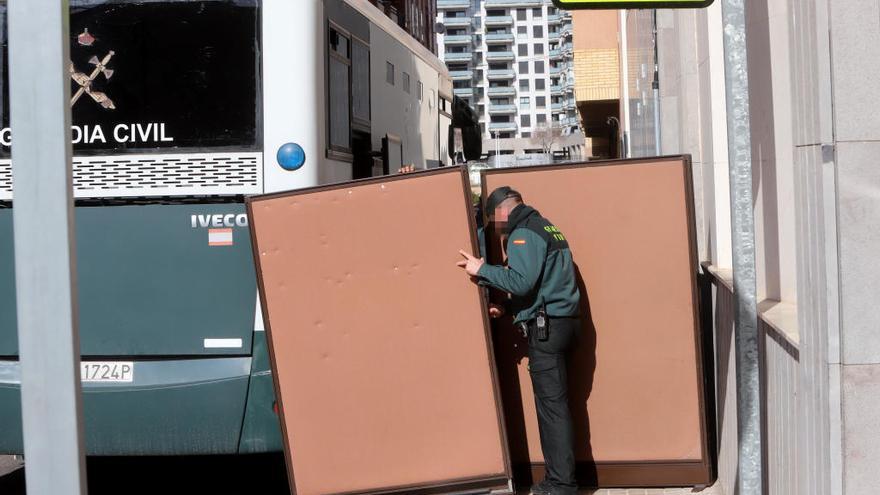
[529,318,580,494]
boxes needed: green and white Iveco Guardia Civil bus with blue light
[0,0,452,455]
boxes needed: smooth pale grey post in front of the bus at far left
[9,0,86,495]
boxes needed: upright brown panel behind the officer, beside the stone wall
[483,157,710,486]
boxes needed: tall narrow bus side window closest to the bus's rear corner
[327,25,351,159]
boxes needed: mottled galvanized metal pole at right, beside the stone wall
[721,0,763,495]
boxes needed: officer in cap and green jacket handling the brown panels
[458,187,580,495]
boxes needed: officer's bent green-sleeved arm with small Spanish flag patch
[478,229,547,297]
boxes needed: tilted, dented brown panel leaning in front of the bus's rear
[248,168,510,495]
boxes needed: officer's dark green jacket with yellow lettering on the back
[478,205,580,322]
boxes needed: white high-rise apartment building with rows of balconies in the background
[437,0,584,161]
